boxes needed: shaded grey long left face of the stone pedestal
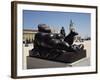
[27,56,71,69]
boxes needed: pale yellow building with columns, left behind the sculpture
[23,29,38,42]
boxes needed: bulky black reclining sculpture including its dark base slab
[29,24,86,63]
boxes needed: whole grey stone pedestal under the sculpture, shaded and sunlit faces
[27,56,90,69]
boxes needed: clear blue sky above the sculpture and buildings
[23,10,91,37]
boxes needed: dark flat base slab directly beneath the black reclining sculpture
[29,50,86,63]
